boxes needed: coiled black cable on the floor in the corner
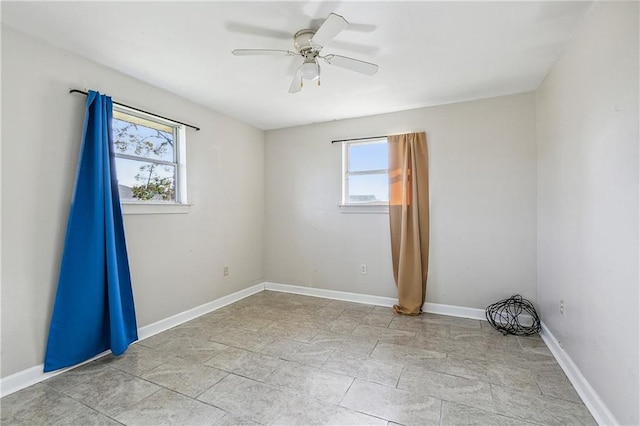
[485,294,541,336]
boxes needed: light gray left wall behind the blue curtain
[1,27,264,377]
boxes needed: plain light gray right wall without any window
[537,2,640,425]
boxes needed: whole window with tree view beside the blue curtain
[112,105,187,204]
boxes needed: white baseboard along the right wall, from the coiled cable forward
[540,323,620,425]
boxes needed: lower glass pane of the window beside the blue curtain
[116,157,176,202]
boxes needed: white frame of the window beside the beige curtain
[339,138,389,213]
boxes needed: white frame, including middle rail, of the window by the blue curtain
[112,104,190,214]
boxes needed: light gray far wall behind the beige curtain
[264,94,536,308]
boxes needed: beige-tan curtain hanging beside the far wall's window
[388,132,429,315]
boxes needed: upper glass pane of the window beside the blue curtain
[112,114,175,162]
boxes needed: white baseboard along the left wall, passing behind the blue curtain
[0,283,264,397]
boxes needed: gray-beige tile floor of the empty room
[0,291,595,426]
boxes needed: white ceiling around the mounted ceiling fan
[2,1,591,129]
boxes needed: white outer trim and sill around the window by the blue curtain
[113,105,191,215]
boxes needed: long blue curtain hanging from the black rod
[44,91,138,371]
